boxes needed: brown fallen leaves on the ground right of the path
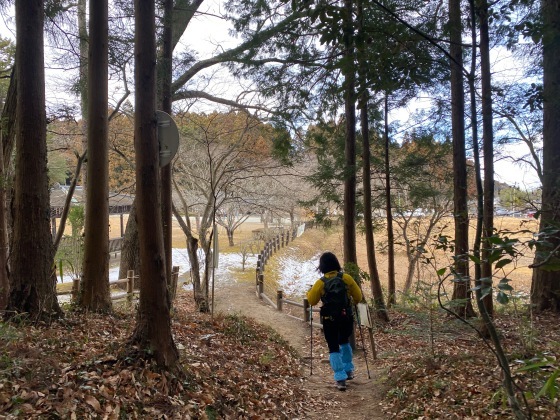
[376,306,560,419]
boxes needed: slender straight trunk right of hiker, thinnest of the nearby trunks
[383,93,397,306]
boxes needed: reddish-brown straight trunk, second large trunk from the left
[80,0,112,312]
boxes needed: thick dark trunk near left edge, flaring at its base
[7,0,61,321]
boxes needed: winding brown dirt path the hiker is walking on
[214,283,387,419]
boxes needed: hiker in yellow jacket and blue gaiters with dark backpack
[307,252,362,391]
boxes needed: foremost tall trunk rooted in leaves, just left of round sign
[131,0,179,370]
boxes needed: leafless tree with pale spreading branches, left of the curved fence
[173,112,288,310]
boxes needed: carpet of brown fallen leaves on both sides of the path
[0,288,560,419]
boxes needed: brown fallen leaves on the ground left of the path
[0,296,320,419]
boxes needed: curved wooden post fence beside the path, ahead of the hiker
[255,222,321,327]
